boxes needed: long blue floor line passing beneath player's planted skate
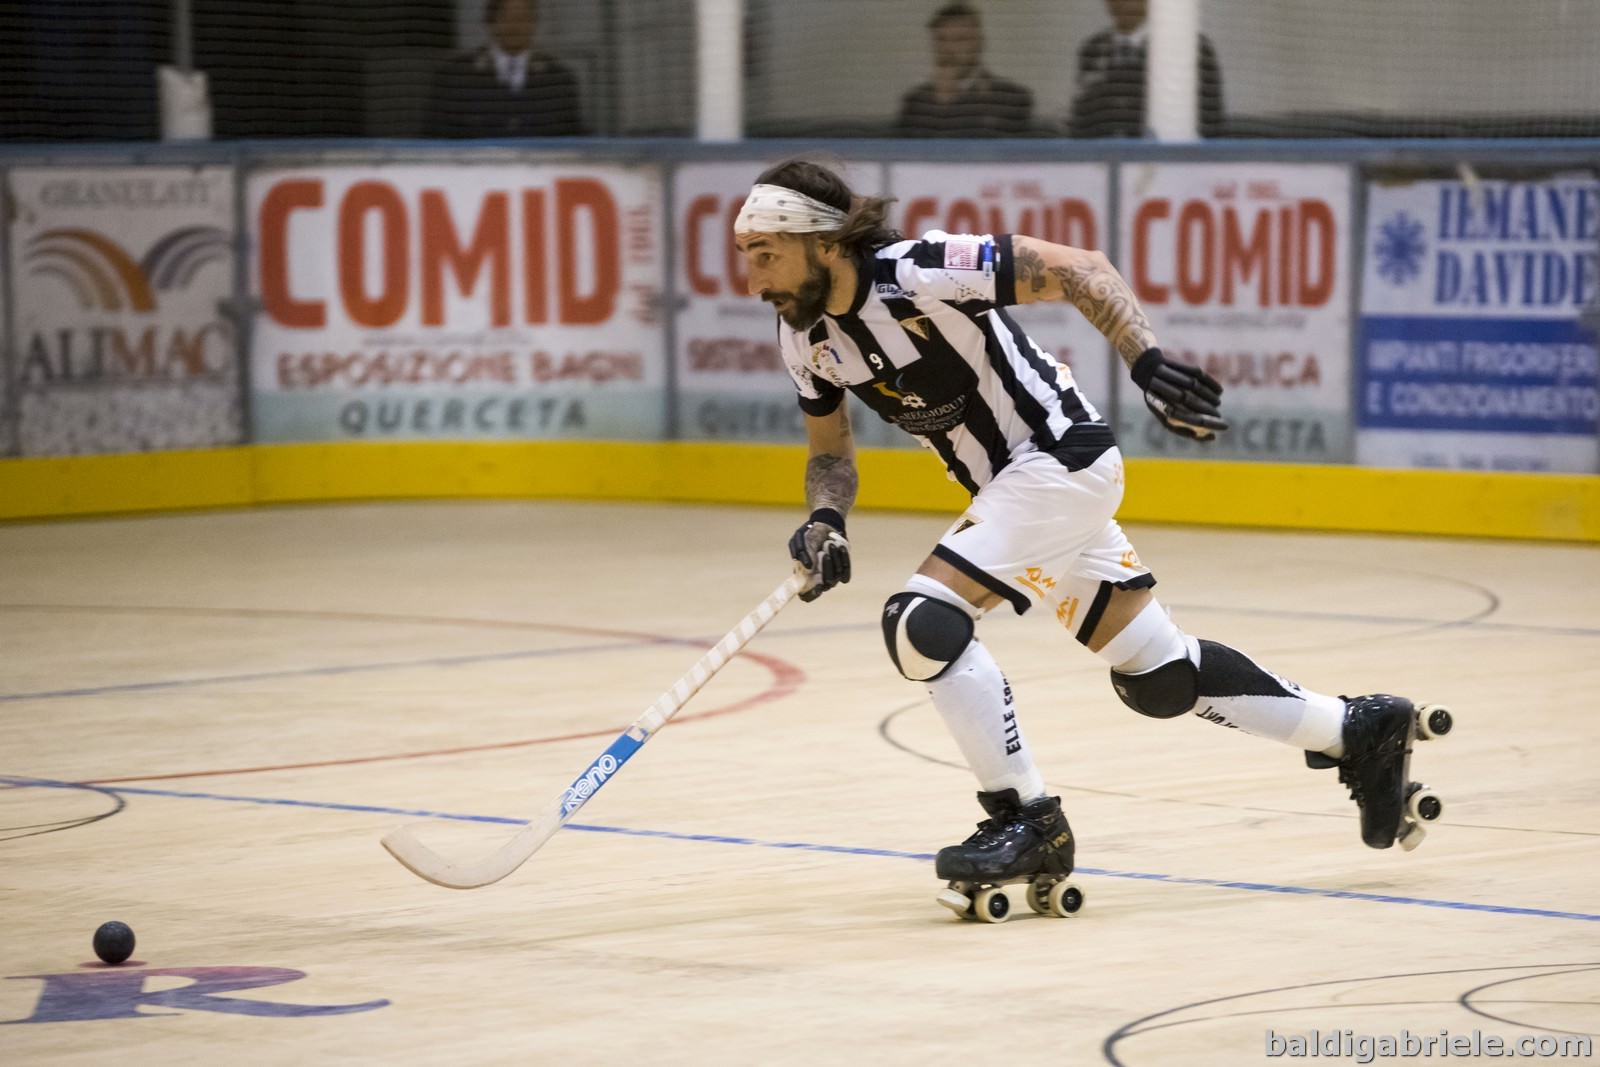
[9,776,1600,923]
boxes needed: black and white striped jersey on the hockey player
[778,230,1115,494]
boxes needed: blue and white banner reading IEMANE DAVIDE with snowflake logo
[1357,174,1600,474]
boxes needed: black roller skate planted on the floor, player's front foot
[934,789,1083,923]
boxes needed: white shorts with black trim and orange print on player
[933,448,1155,645]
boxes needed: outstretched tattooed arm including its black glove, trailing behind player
[1011,235,1227,440]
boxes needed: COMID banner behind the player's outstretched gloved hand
[1117,163,1352,462]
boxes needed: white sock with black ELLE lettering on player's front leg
[928,640,1045,801]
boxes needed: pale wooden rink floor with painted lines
[0,502,1600,1067]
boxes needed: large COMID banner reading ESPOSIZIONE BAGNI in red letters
[246,165,666,442]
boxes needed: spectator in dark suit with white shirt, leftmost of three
[427,0,587,138]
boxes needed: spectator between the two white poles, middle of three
[894,3,1034,138]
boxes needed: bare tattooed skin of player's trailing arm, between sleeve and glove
[1011,235,1155,366]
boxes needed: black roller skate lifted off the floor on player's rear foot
[1306,694,1454,853]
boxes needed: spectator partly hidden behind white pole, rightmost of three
[1067,0,1222,138]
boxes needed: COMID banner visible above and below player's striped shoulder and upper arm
[890,163,1114,413]
